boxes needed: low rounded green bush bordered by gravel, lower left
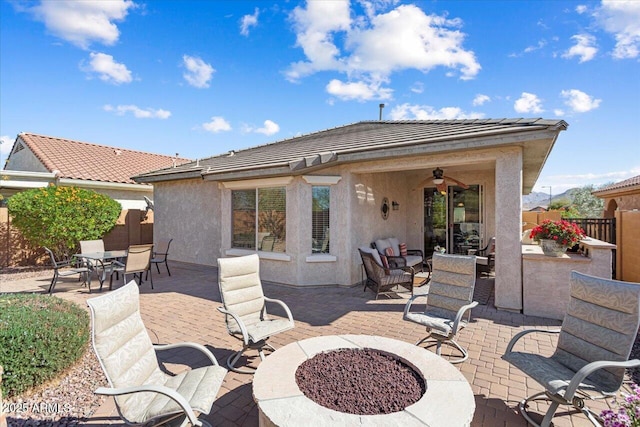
[0,294,89,397]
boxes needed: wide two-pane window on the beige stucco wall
[231,187,287,252]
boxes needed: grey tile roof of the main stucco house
[134,119,568,182]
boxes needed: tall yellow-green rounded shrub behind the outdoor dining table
[8,186,122,258]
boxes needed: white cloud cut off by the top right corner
[595,0,640,59]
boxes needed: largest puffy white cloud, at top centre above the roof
[286,1,481,95]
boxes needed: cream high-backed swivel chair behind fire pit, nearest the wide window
[218,254,294,374]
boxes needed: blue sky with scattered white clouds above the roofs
[0,0,640,194]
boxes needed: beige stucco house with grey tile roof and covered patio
[134,119,568,310]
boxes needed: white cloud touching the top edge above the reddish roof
[29,0,136,49]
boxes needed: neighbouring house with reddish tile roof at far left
[0,133,189,209]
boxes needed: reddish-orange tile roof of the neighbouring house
[11,133,190,184]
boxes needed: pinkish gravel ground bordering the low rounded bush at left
[0,267,108,427]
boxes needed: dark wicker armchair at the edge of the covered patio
[358,246,415,299]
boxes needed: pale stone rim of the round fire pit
[253,335,475,426]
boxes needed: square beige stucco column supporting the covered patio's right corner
[495,148,522,311]
